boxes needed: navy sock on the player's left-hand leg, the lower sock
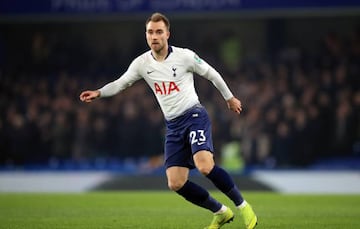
[176,180,222,212]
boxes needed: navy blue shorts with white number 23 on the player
[165,105,214,169]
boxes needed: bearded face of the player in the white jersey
[146,21,170,53]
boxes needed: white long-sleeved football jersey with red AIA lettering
[99,46,233,120]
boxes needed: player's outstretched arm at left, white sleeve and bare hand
[80,58,141,103]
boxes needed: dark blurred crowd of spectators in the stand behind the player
[0,25,360,167]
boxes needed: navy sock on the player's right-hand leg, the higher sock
[206,165,244,206]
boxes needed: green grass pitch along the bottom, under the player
[0,191,360,229]
